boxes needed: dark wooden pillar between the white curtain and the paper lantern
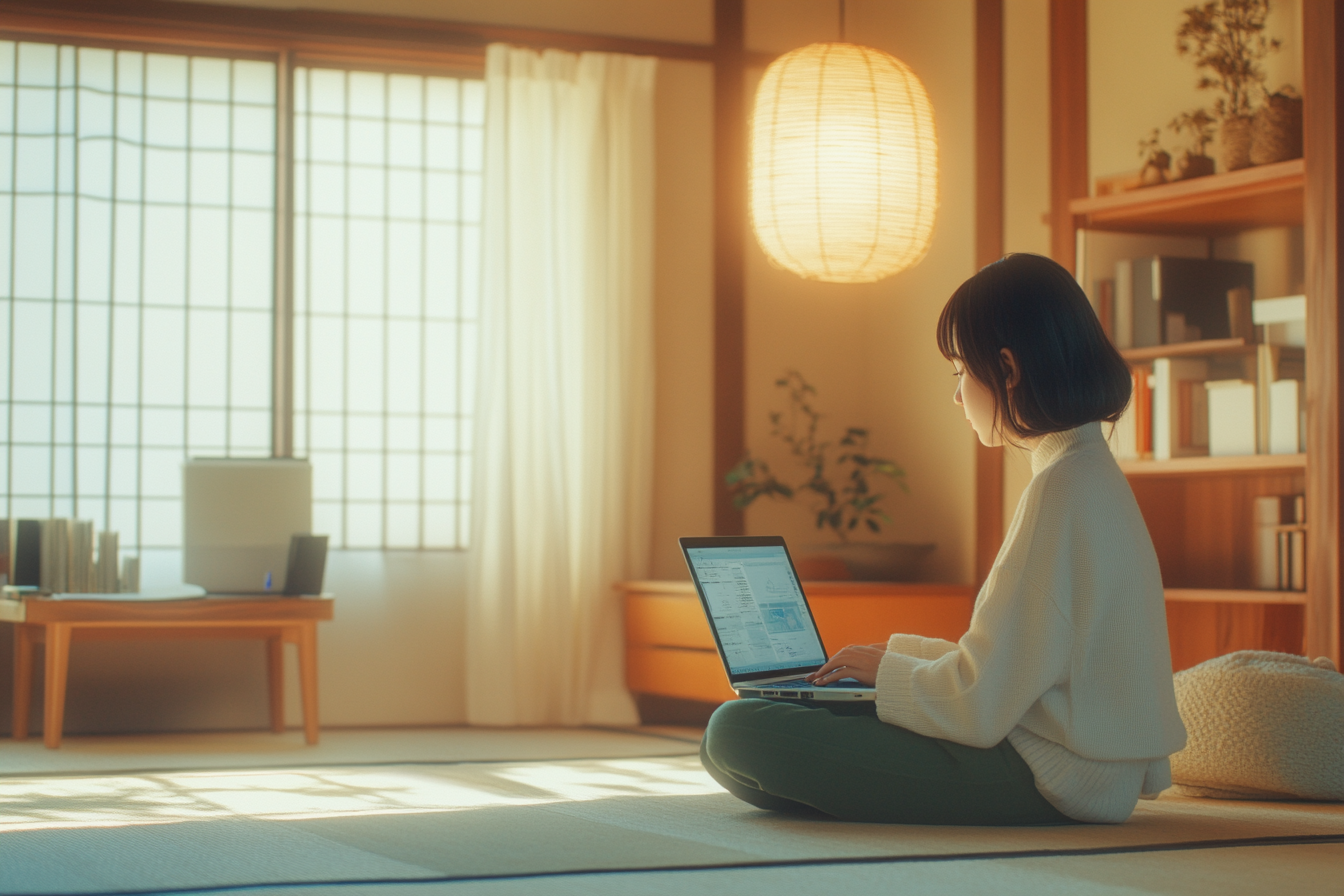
[714,0,747,535]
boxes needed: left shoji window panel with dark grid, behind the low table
[0,42,276,579]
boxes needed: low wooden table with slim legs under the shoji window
[0,595,336,750]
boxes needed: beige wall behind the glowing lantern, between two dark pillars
[746,0,974,582]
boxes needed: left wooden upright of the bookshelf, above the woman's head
[1050,0,1087,271]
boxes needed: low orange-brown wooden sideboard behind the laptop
[616,582,976,703]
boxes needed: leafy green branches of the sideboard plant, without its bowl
[724,371,910,541]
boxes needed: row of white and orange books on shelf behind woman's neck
[1110,345,1306,461]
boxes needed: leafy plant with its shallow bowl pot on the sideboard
[724,371,933,580]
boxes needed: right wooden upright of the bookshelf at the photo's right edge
[1302,0,1344,662]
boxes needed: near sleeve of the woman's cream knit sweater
[878,567,1071,748]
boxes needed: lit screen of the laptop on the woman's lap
[685,544,827,678]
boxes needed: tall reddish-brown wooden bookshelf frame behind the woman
[1050,0,1344,670]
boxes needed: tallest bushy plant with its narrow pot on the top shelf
[1176,0,1279,171]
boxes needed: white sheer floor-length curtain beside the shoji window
[466,44,655,725]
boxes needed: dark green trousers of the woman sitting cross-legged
[700,700,1073,825]
